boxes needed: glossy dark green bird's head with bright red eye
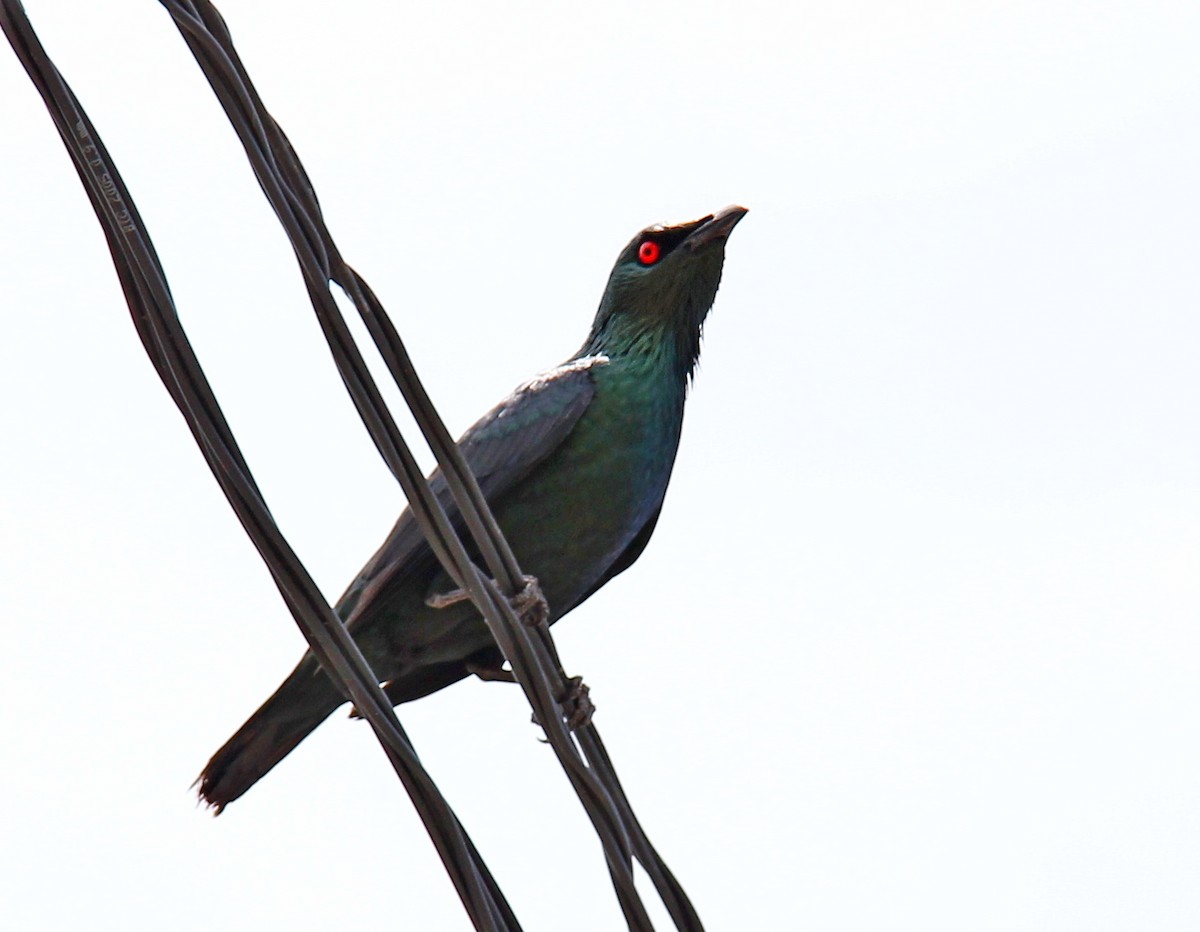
[584,206,746,378]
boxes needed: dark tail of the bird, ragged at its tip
[197,657,346,814]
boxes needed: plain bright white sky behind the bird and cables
[0,0,1200,932]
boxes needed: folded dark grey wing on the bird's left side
[337,356,608,624]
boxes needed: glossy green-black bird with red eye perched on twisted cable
[197,205,746,814]
